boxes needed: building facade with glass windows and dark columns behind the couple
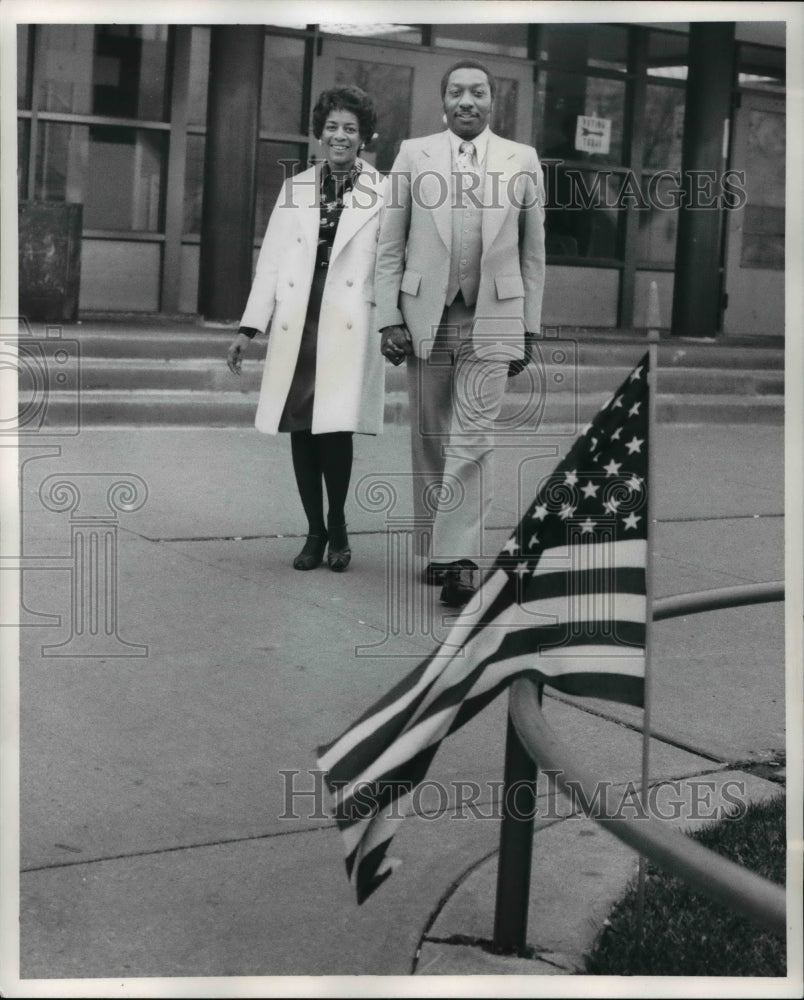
[17,22,785,339]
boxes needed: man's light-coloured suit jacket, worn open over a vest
[374,132,545,361]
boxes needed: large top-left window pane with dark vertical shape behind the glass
[39,24,168,121]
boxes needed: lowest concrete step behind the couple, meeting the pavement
[20,389,784,433]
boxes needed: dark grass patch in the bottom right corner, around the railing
[586,795,787,976]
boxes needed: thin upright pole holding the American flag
[636,329,659,943]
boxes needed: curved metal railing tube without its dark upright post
[502,583,787,933]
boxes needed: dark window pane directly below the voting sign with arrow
[545,164,630,259]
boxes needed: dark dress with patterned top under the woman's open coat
[277,163,360,431]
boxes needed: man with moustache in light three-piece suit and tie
[374,59,545,607]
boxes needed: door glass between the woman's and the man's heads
[335,59,413,173]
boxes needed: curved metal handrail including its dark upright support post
[494,582,787,952]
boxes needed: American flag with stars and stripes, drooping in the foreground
[318,354,649,903]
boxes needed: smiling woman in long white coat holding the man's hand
[227,87,384,572]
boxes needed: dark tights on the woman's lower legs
[290,431,352,535]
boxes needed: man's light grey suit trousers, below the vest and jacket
[407,295,508,563]
